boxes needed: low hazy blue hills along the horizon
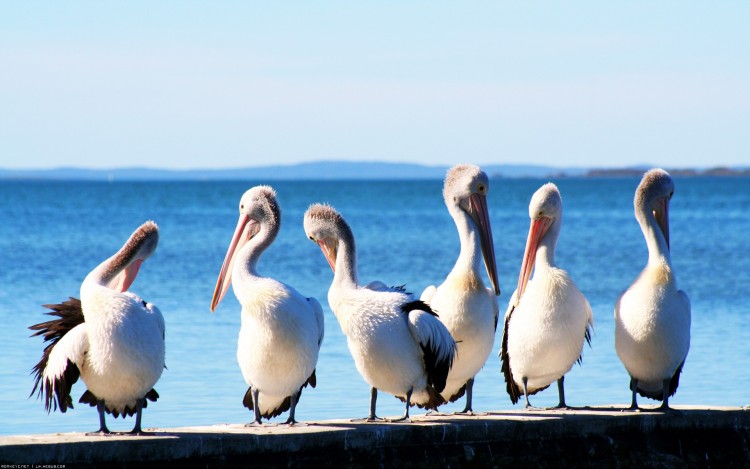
[0,161,750,181]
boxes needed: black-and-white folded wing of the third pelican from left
[401,300,456,392]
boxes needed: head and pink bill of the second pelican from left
[211,186,281,311]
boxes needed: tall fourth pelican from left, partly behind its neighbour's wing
[421,164,500,414]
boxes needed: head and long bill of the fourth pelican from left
[443,164,500,295]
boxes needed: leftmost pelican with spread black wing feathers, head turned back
[30,221,164,435]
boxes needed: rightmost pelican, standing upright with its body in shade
[615,169,690,410]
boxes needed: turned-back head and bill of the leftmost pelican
[101,221,159,292]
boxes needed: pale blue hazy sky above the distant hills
[0,0,750,168]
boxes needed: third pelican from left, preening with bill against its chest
[304,204,456,421]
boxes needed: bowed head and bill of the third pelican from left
[304,204,354,273]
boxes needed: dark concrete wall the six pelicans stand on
[0,406,750,469]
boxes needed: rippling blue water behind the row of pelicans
[0,179,750,434]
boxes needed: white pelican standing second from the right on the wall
[500,183,593,409]
